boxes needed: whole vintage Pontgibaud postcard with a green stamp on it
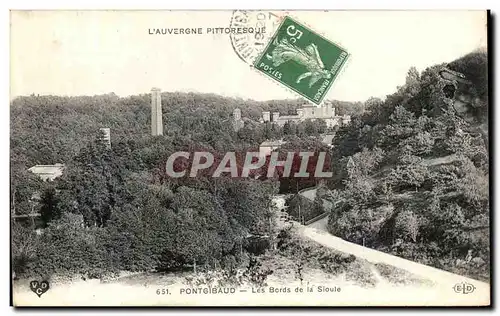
[10,10,492,307]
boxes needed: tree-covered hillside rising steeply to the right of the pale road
[328,51,490,280]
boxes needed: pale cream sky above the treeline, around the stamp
[10,11,487,101]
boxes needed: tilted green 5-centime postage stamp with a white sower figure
[254,17,349,105]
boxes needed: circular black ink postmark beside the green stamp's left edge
[230,10,285,65]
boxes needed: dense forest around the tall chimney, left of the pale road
[11,87,347,276]
